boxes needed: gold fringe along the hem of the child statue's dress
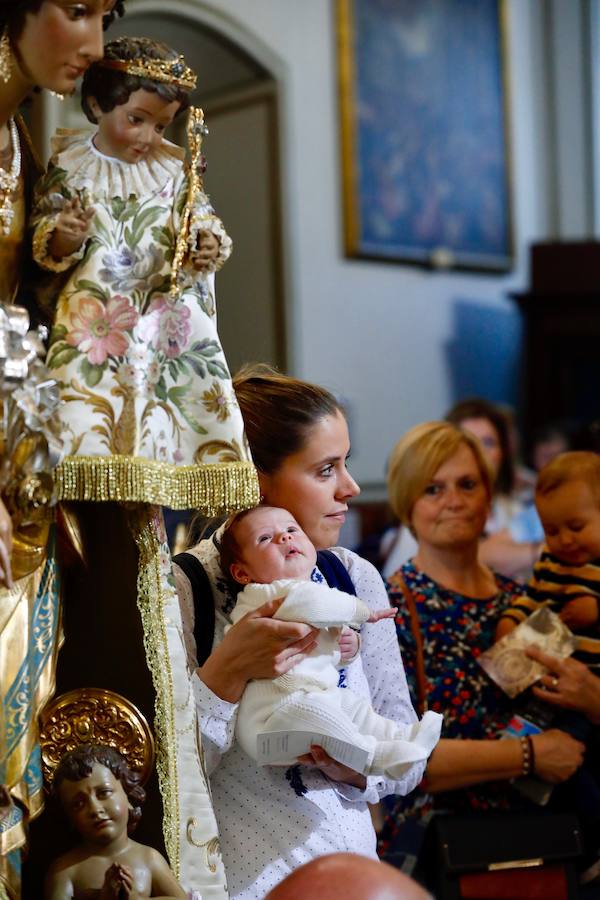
[54,456,260,516]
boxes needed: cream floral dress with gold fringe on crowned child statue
[33,131,258,514]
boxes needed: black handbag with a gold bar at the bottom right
[426,810,583,900]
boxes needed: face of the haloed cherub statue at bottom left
[58,763,131,846]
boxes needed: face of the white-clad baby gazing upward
[231,506,317,584]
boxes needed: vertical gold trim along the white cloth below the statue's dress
[129,510,181,878]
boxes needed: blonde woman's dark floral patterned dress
[381,561,523,853]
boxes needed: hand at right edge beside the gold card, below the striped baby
[526,647,600,725]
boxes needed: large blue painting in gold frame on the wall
[337,0,512,272]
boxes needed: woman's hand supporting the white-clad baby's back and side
[197,597,319,703]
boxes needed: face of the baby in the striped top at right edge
[535,481,600,566]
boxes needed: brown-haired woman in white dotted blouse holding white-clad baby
[176,370,424,900]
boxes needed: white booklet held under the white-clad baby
[256,731,369,772]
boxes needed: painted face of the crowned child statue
[90,88,180,163]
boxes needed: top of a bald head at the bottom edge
[265,853,429,900]
